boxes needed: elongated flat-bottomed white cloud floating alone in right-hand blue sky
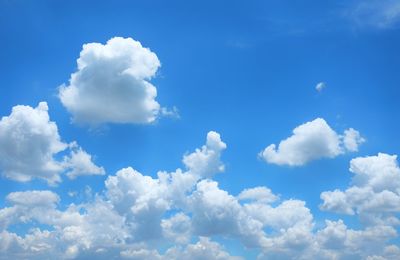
[259,118,365,166]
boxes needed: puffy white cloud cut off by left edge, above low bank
[0,102,104,184]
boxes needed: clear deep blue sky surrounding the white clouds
[0,0,400,259]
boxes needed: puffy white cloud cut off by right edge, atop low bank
[321,153,400,225]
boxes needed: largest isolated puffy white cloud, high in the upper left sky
[58,37,172,125]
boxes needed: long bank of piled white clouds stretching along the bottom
[0,132,400,260]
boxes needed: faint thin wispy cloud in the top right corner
[347,0,400,29]
